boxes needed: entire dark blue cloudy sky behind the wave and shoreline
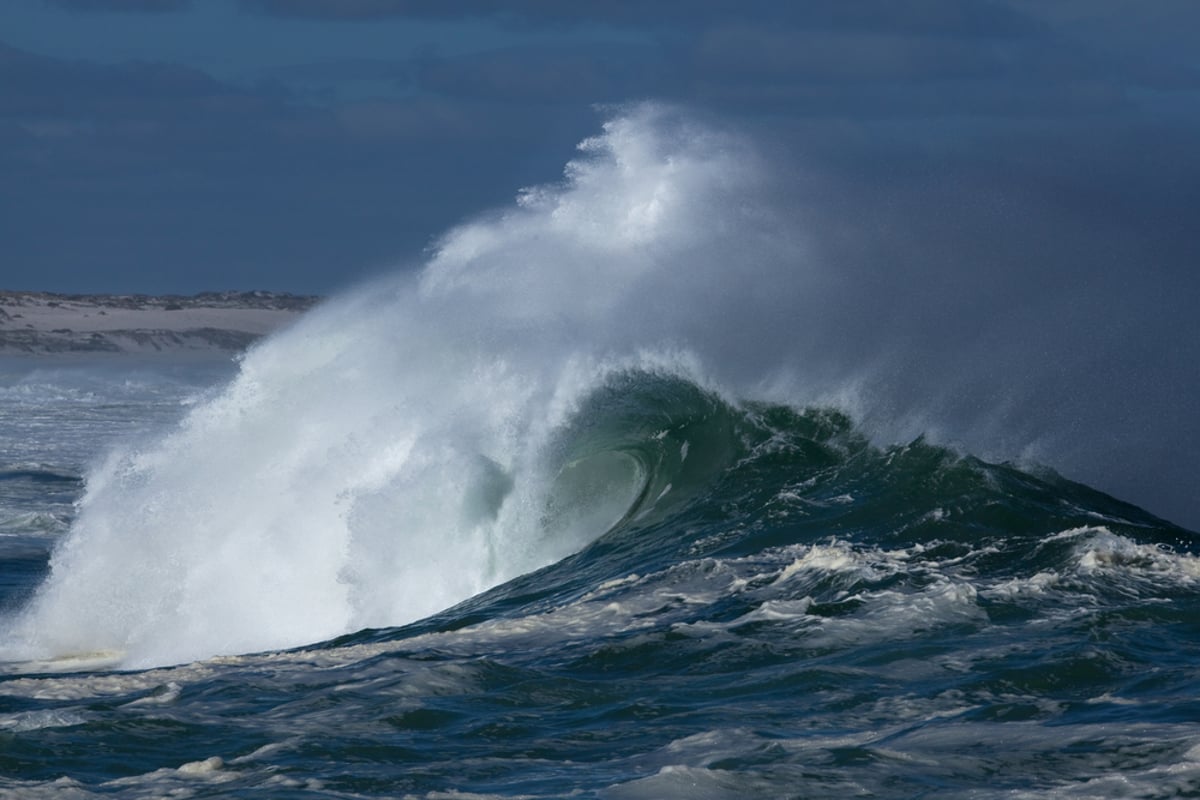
[0,0,1200,527]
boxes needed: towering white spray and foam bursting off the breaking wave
[6,107,794,666]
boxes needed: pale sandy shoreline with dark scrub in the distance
[0,290,322,356]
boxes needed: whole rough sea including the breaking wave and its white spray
[0,109,1200,800]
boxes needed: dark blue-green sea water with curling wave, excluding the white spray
[0,362,1200,799]
